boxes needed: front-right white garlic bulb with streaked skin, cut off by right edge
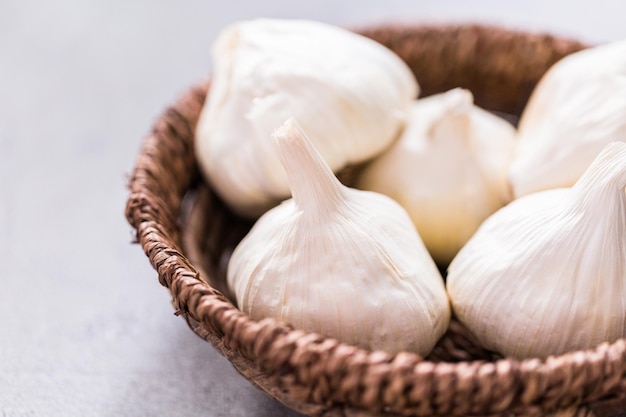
[447,142,626,358]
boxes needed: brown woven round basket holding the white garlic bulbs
[126,25,626,417]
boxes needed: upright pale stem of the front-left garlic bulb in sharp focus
[272,117,344,216]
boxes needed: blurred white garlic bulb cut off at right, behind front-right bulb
[510,40,626,197]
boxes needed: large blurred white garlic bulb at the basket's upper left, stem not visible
[196,19,419,217]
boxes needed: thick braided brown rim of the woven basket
[125,24,626,415]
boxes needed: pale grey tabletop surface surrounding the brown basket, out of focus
[0,0,626,417]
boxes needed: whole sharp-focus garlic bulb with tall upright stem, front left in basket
[228,119,450,355]
